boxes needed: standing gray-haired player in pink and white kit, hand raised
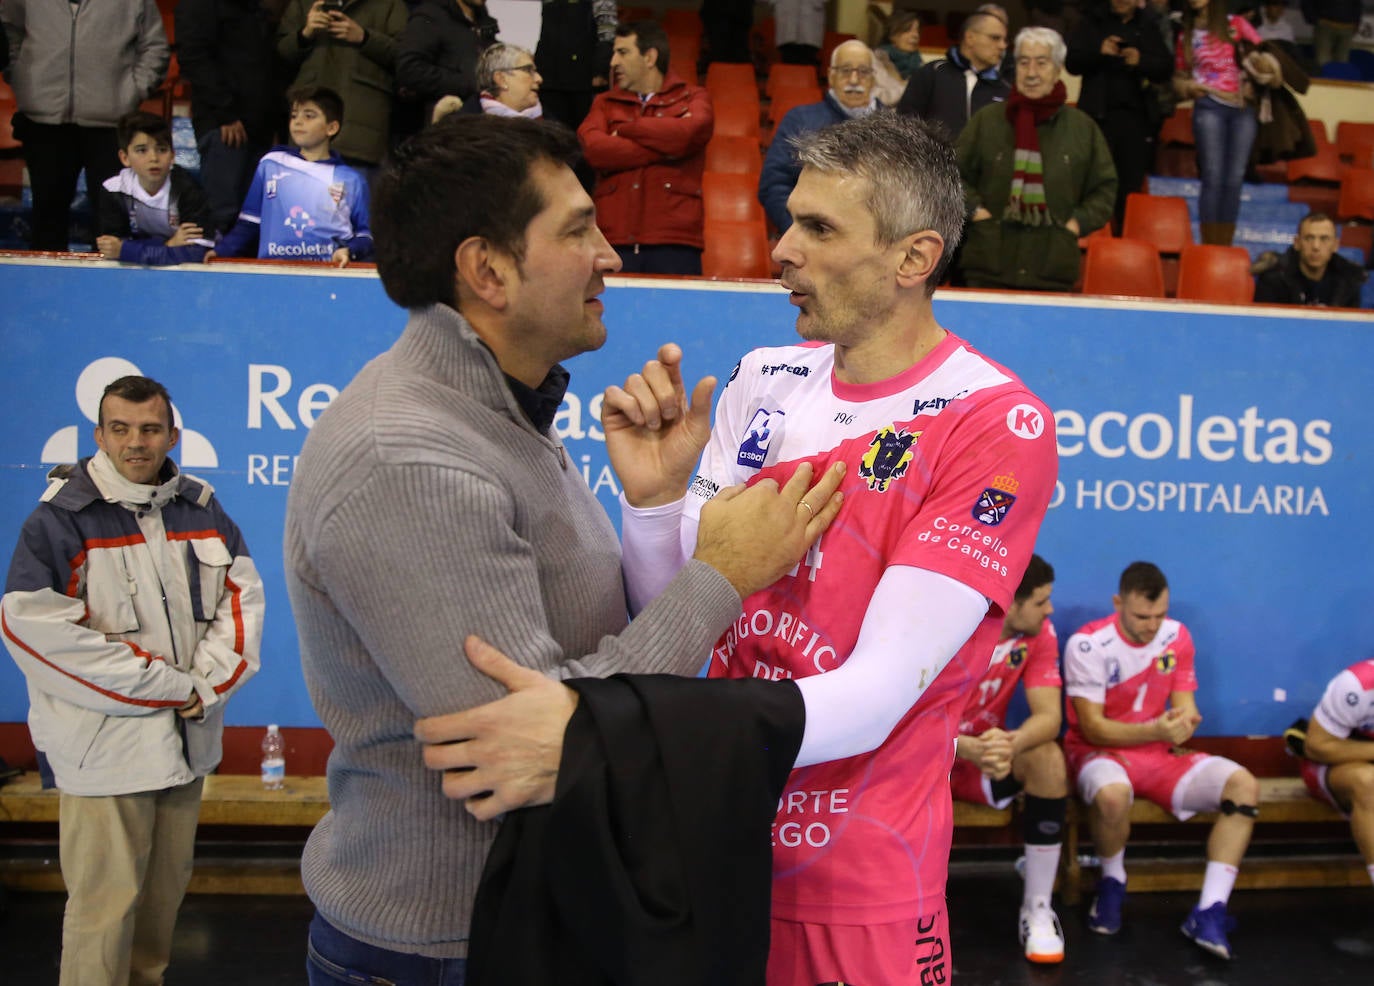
[603,114,1057,986]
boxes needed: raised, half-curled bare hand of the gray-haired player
[602,342,716,507]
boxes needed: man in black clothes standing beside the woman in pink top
[1065,0,1173,229]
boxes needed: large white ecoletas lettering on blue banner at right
[1054,394,1334,466]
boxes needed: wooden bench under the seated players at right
[1059,777,1369,904]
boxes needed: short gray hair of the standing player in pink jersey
[793,110,963,295]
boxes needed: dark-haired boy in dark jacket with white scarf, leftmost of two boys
[95,110,212,266]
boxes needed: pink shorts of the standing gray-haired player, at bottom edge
[767,908,954,986]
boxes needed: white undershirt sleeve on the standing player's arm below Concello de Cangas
[796,566,988,766]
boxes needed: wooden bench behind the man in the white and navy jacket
[0,773,330,894]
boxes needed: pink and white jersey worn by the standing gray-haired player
[684,335,1058,924]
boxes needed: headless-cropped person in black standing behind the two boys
[176,0,284,231]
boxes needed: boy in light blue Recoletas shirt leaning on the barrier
[206,87,372,266]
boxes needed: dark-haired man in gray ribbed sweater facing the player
[284,114,838,983]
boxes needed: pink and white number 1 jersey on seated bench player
[1063,614,1198,758]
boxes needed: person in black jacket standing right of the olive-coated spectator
[396,0,500,119]
